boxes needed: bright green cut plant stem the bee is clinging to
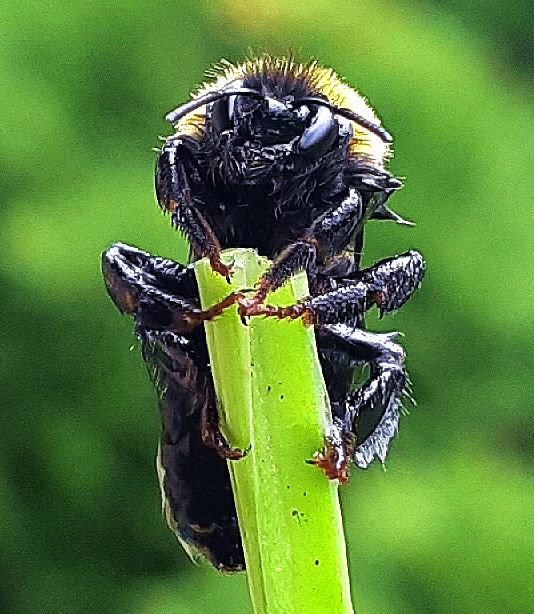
[196,250,353,614]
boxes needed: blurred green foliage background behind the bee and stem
[0,0,534,614]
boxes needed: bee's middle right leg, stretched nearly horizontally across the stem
[240,251,425,326]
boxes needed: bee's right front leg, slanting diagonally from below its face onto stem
[245,188,365,307]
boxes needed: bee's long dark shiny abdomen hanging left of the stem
[138,329,245,572]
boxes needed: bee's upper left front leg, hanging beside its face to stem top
[156,135,231,277]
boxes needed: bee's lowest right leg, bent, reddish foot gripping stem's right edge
[315,324,407,482]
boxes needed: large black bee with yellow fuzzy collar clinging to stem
[103,56,424,571]
